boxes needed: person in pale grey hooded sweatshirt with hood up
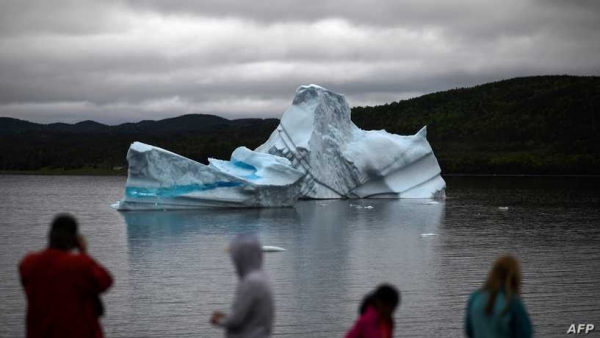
[210,234,274,338]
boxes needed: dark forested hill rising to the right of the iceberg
[352,76,600,175]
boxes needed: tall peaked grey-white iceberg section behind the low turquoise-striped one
[256,85,446,198]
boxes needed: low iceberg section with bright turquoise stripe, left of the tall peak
[116,142,304,210]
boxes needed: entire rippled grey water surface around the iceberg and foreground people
[0,175,600,338]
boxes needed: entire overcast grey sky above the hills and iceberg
[0,0,600,124]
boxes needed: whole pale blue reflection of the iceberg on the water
[121,199,445,337]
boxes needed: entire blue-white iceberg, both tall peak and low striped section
[117,85,446,210]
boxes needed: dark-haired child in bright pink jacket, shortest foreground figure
[346,284,400,338]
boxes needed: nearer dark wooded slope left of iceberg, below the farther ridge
[0,119,279,172]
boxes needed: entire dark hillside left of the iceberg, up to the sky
[0,115,279,171]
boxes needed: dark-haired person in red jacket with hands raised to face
[19,214,113,338]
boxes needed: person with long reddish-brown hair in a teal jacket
[465,255,533,338]
